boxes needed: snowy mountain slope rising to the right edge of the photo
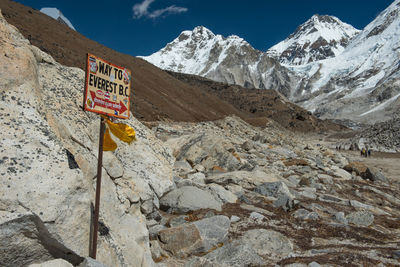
[289,0,400,122]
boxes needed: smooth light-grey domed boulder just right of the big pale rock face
[160,186,222,213]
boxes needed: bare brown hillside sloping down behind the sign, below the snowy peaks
[0,0,346,132]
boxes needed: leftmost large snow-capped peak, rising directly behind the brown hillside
[142,26,294,92]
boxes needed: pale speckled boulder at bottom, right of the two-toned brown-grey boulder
[241,229,293,258]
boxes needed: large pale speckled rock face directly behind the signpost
[0,9,175,266]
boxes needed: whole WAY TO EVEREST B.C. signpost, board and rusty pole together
[83,54,131,259]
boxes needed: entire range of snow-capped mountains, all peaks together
[143,0,400,123]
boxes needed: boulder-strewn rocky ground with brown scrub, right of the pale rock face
[149,118,400,266]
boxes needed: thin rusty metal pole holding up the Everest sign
[89,118,105,259]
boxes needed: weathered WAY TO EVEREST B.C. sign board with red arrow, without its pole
[83,54,132,119]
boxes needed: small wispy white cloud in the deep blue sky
[132,0,188,19]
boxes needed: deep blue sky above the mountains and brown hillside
[16,0,393,56]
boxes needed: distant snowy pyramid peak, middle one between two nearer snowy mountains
[267,15,360,65]
